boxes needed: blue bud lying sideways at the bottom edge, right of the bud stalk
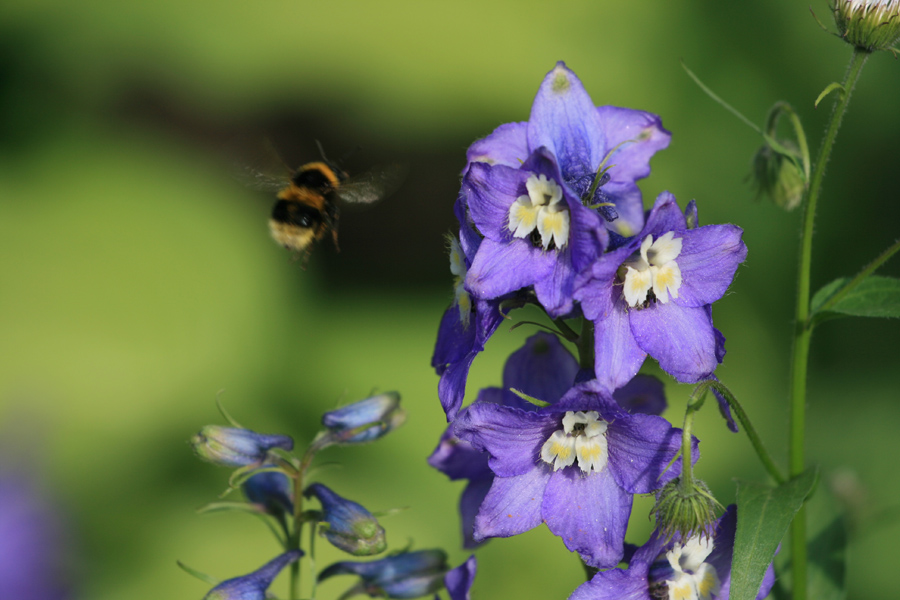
[319,550,447,599]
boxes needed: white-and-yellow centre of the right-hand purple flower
[622,231,681,308]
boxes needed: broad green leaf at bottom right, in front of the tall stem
[729,468,817,600]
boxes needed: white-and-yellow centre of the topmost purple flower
[509,175,569,250]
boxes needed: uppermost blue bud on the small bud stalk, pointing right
[322,392,406,444]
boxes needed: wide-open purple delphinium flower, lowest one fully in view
[454,380,699,568]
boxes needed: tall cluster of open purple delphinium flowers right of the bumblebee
[429,62,767,598]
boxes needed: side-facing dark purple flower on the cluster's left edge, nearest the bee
[431,193,503,421]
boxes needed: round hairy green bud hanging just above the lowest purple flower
[651,477,722,539]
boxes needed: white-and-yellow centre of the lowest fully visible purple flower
[541,410,609,473]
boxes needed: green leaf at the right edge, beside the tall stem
[811,275,900,321]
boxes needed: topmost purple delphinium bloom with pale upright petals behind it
[462,62,670,317]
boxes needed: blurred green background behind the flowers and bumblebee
[0,0,900,600]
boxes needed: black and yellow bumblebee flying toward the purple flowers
[240,146,406,258]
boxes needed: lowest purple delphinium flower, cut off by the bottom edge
[569,505,775,600]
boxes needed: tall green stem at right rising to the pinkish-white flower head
[789,48,869,600]
